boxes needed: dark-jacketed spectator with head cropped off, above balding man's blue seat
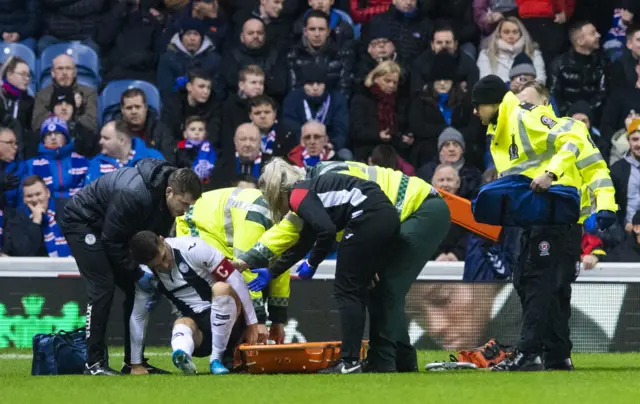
[38,0,109,54]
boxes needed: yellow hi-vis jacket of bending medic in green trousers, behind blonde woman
[240,161,437,276]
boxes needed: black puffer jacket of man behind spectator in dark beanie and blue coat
[287,38,354,98]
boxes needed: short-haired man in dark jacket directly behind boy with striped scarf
[162,69,222,151]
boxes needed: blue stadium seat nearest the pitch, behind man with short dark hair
[98,80,162,124]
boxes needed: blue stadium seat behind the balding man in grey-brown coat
[38,42,100,88]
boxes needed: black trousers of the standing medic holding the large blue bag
[513,224,582,360]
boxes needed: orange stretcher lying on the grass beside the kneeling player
[234,341,368,374]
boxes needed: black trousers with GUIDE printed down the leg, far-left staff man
[62,224,135,366]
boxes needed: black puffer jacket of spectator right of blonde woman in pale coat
[551,48,609,117]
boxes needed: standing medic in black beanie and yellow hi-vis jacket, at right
[472,76,616,371]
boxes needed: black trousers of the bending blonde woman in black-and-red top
[334,204,400,361]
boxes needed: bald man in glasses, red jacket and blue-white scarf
[287,120,336,167]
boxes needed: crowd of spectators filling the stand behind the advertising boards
[0,0,640,272]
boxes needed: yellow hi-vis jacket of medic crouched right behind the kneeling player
[176,188,291,323]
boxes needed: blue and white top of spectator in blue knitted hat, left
[33,142,89,198]
